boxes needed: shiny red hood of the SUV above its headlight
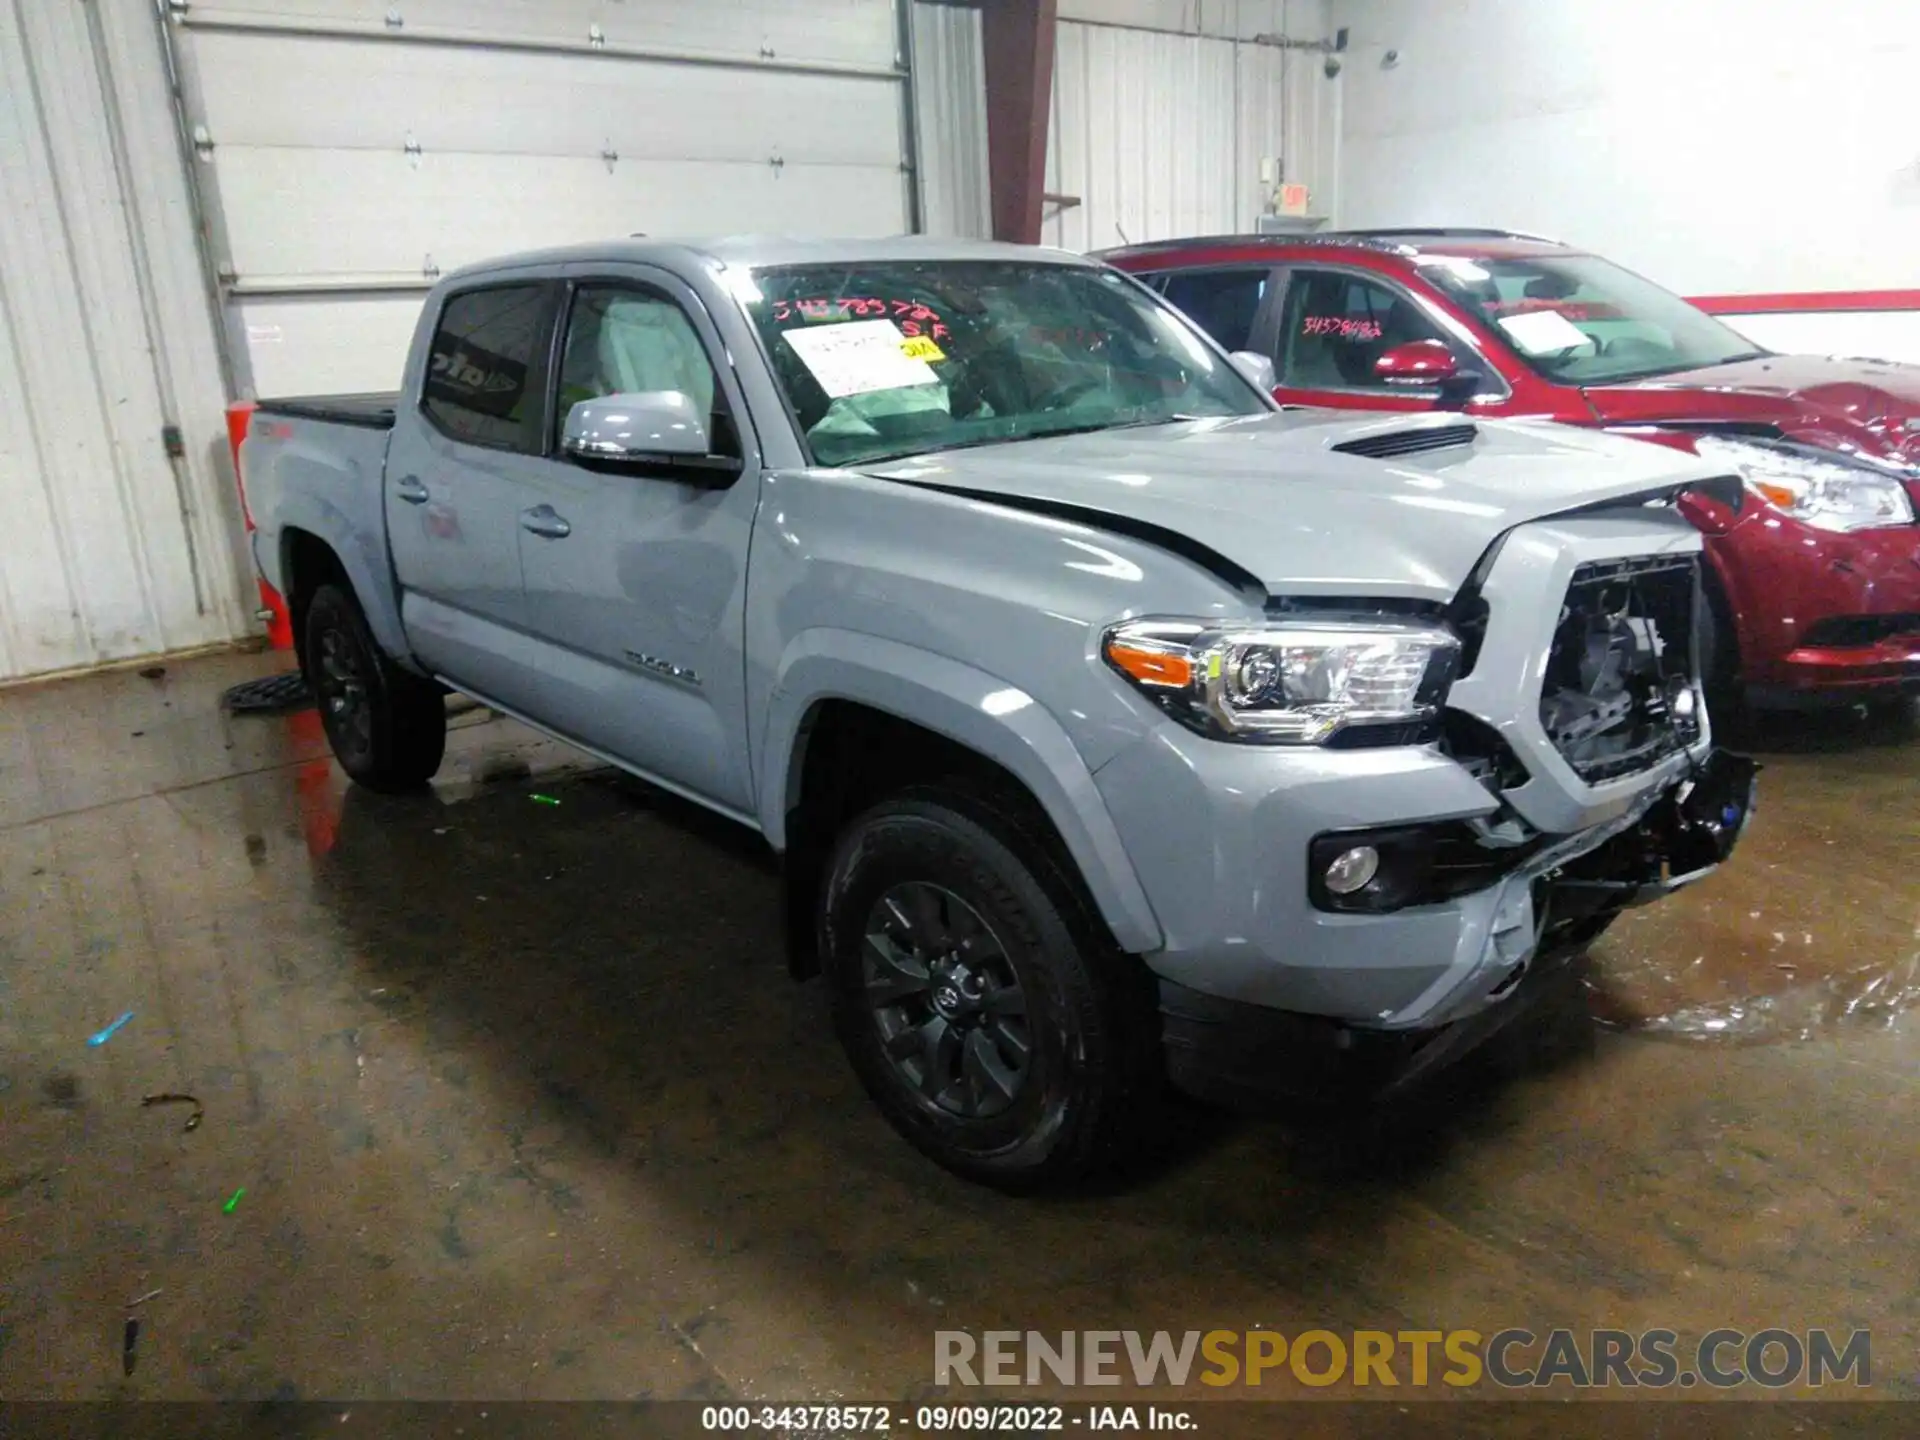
[1586,355,1920,465]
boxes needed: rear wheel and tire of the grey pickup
[305,584,447,793]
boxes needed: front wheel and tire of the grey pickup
[820,789,1160,1190]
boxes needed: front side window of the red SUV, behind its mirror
[1269,265,1501,411]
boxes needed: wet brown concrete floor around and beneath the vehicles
[0,655,1920,1400]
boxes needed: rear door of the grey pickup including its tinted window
[386,280,561,705]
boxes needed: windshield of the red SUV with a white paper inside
[1419,255,1764,386]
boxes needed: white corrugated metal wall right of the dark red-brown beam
[1041,21,1338,250]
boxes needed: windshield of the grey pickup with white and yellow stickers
[729,261,1269,465]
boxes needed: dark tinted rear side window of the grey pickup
[420,284,549,451]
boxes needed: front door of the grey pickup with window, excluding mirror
[518,267,760,814]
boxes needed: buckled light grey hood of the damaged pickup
[862,413,1722,601]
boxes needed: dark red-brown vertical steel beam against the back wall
[981,0,1058,246]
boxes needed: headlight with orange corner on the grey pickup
[1100,620,1459,745]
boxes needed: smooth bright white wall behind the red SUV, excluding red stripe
[1334,0,1920,353]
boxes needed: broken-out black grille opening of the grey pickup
[1540,555,1699,783]
